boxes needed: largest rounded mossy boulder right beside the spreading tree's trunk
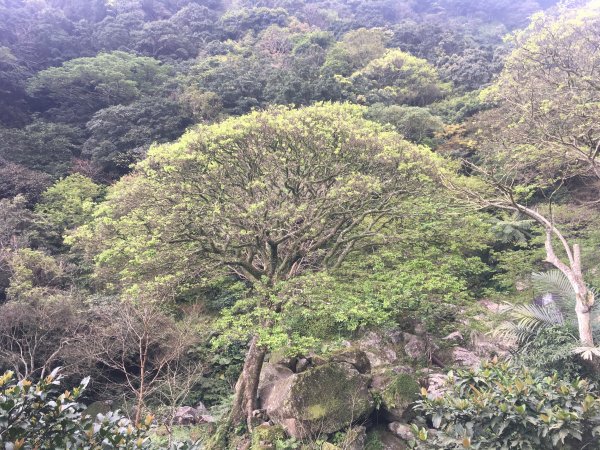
[259,362,374,439]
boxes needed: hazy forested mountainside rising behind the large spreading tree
[0,0,550,181]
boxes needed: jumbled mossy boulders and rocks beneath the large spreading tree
[169,301,510,450]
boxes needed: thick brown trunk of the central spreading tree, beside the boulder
[231,336,267,431]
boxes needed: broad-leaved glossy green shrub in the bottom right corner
[417,362,600,449]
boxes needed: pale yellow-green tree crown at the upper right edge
[479,3,600,192]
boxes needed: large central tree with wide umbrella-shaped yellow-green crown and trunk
[74,104,435,425]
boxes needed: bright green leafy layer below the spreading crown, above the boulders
[220,202,490,353]
